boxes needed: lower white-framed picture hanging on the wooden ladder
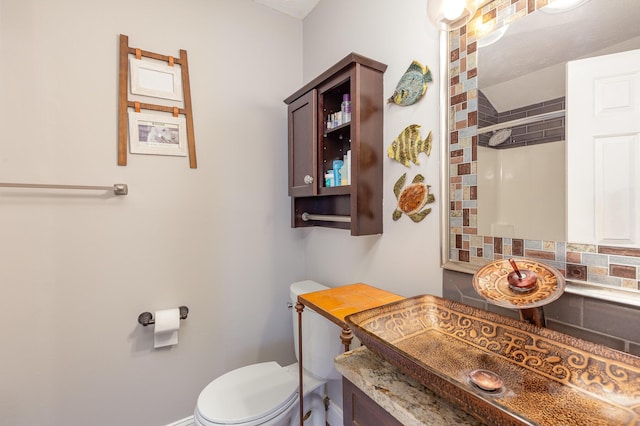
[129,111,187,157]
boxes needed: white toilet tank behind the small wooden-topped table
[290,280,344,380]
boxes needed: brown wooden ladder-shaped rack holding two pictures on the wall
[118,34,198,169]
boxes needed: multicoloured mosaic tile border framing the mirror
[449,0,640,290]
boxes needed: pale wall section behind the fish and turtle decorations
[300,0,443,296]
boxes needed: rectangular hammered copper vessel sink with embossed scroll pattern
[345,295,640,426]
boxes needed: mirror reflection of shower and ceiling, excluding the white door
[477,0,640,241]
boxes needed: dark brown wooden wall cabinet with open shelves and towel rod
[284,53,387,235]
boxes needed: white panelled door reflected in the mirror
[567,50,640,247]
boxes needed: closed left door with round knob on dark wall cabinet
[288,89,319,197]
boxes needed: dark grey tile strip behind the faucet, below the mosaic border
[442,270,640,356]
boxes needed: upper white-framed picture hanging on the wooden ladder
[129,58,182,101]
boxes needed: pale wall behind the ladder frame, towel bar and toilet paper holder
[0,0,306,426]
